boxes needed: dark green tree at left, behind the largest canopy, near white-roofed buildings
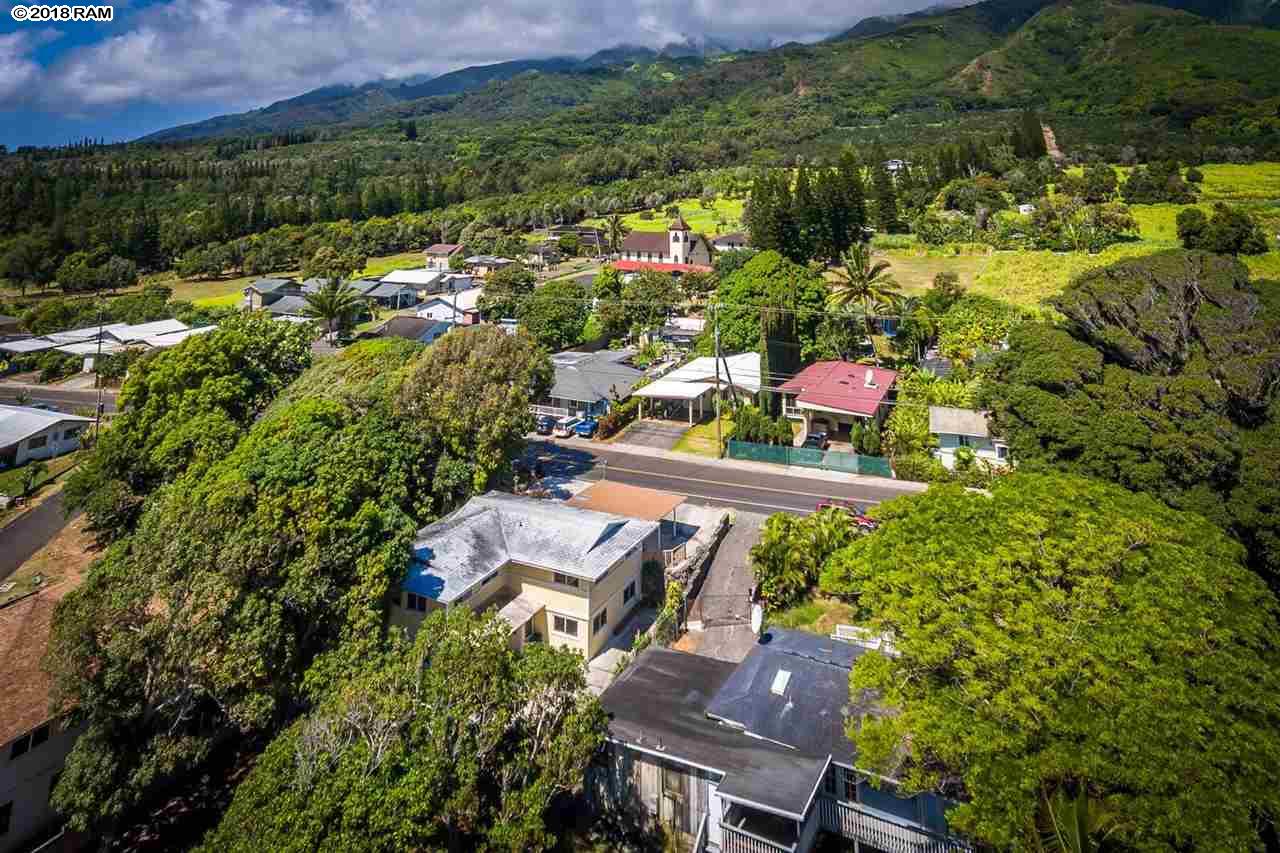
[67,314,311,538]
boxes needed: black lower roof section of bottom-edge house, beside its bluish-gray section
[600,647,827,818]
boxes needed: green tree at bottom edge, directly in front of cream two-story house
[202,607,605,853]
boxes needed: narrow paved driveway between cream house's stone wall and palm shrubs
[680,512,768,663]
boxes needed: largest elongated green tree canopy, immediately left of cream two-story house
[47,324,550,826]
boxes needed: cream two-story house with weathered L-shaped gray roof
[390,492,658,660]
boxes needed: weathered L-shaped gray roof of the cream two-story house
[401,492,658,603]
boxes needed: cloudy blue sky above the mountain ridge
[0,0,928,150]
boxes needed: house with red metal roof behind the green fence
[778,361,897,434]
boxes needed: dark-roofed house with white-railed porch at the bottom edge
[588,629,973,853]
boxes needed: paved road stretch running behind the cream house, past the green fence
[530,441,919,515]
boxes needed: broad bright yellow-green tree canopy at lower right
[822,474,1280,852]
